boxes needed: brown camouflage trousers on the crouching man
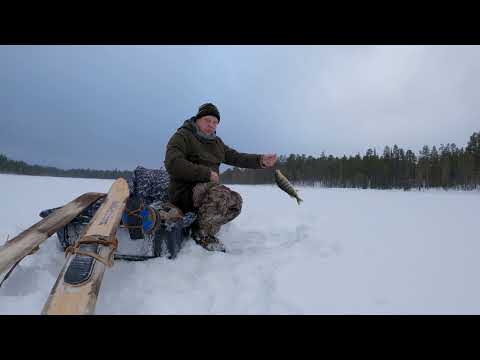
[192,182,243,237]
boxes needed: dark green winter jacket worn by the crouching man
[165,117,262,212]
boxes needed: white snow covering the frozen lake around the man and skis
[0,175,480,314]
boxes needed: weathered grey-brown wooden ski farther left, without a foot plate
[0,192,105,280]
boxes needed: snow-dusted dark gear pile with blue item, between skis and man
[40,166,196,260]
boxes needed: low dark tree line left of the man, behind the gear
[0,154,132,179]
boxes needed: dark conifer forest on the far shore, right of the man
[221,132,480,190]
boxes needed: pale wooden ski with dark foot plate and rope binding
[42,178,129,315]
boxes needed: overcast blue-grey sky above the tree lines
[0,45,480,170]
